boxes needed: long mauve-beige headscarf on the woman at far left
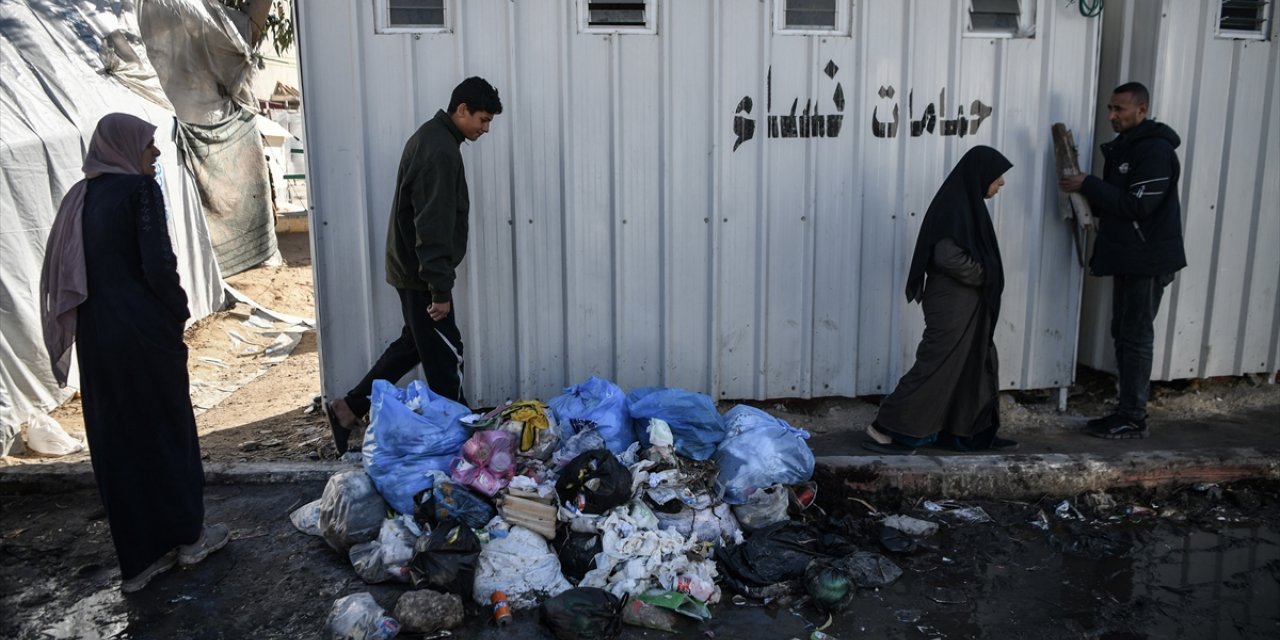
[40,114,156,387]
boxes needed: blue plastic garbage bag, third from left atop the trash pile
[627,387,724,460]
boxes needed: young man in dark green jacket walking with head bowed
[326,77,502,454]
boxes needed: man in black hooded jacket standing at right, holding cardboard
[1059,82,1187,439]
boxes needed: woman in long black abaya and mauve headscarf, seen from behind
[40,114,230,593]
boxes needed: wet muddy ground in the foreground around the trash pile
[0,483,1280,639]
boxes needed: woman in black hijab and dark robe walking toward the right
[863,146,1018,454]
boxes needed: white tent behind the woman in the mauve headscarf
[0,0,223,453]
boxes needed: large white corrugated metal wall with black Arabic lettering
[298,0,1101,406]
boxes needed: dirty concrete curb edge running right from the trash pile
[814,448,1280,502]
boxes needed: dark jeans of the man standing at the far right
[1111,274,1174,420]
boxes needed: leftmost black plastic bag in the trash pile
[408,520,480,602]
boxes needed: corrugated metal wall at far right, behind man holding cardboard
[1080,0,1280,380]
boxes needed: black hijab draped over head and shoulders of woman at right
[906,146,1014,317]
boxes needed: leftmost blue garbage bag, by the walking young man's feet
[361,380,471,515]
